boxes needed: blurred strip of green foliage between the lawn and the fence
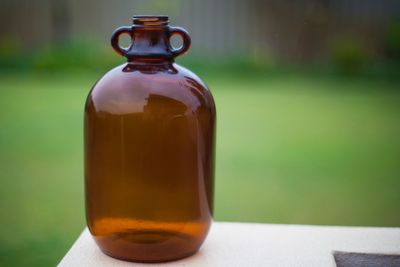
[0,34,400,79]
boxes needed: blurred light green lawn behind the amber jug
[0,70,400,266]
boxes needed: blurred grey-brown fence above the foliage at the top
[0,0,400,61]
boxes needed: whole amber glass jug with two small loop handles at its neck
[85,16,215,262]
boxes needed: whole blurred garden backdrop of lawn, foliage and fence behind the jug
[0,0,400,266]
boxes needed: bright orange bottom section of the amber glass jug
[91,219,209,263]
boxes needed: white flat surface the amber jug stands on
[59,222,400,267]
